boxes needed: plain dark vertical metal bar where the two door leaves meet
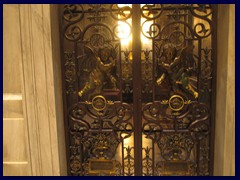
[132,4,142,176]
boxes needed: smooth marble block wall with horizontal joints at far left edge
[3,5,31,175]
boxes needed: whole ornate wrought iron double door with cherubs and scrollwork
[59,4,216,176]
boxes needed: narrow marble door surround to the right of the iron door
[214,4,235,176]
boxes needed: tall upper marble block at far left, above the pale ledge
[3,5,21,93]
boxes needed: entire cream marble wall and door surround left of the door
[3,4,66,175]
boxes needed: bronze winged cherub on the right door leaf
[156,43,198,99]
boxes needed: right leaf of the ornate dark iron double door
[142,4,214,175]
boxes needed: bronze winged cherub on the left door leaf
[78,47,117,97]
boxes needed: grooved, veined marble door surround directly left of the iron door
[20,4,66,175]
